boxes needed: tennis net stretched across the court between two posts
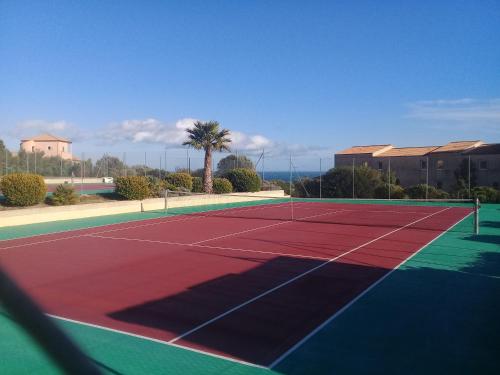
[165,191,478,234]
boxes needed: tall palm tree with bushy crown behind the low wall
[183,121,231,193]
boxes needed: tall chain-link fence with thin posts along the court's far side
[0,149,500,203]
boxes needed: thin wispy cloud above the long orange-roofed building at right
[406,98,500,122]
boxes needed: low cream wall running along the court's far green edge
[0,190,285,227]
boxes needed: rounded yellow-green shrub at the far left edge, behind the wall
[0,173,47,207]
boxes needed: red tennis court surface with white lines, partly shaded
[0,202,471,366]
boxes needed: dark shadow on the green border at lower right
[274,250,500,375]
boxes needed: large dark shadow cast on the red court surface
[109,255,388,365]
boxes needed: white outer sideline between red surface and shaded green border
[268,212,472,369]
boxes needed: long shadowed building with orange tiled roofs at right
[335,141,500,190]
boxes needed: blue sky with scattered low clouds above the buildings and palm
[0,0,500,169]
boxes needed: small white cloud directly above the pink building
[11,120,84,141]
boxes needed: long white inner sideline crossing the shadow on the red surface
[169,207,450,343]
